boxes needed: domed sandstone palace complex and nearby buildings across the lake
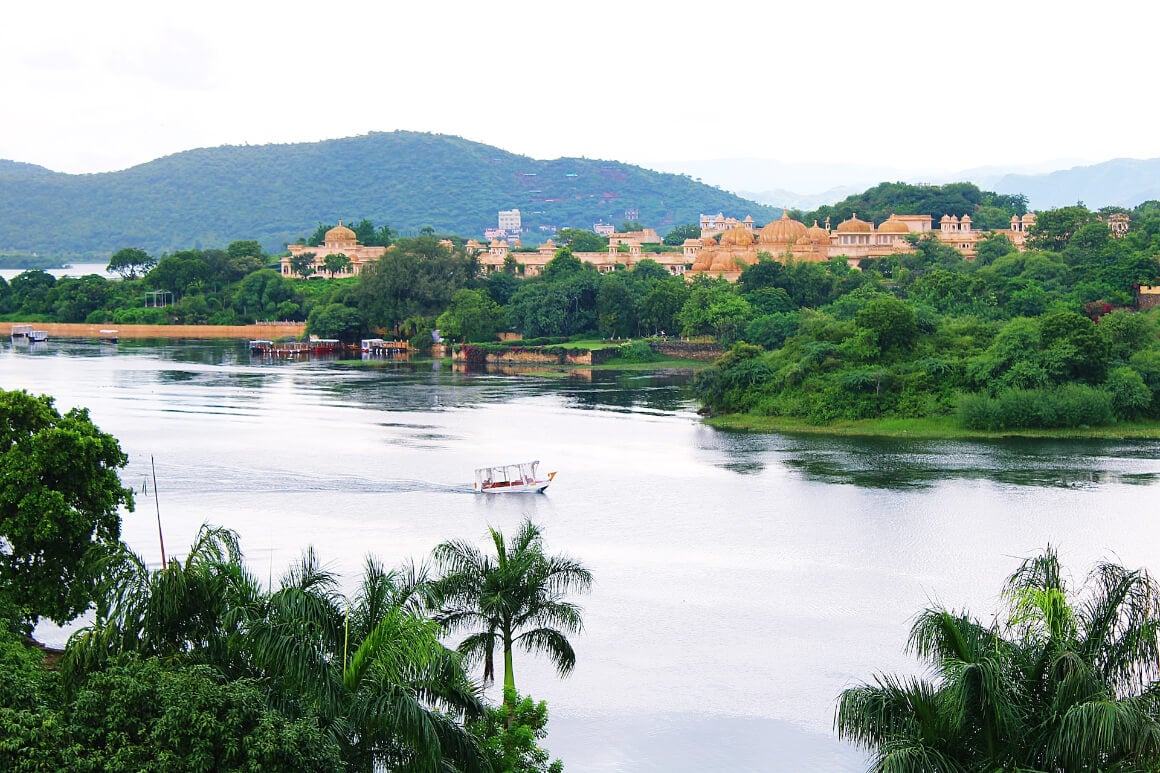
[282,210,1053,281]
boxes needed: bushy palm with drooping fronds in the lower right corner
[835,547,1160,772]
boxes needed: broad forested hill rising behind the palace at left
[0,131,775,259]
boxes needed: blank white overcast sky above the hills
[0,0,1160,173]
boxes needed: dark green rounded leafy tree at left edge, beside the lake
[0,391,133,626]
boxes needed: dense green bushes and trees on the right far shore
[695,202,1160,434]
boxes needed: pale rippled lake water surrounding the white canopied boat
[0,340,1160,772]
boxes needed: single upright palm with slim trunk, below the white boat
[433,520,592,702]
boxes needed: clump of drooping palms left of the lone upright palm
[64,526,486,773]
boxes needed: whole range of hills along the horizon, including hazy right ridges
[0,131,1160,260]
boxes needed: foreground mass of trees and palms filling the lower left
[0,391,592,773]
